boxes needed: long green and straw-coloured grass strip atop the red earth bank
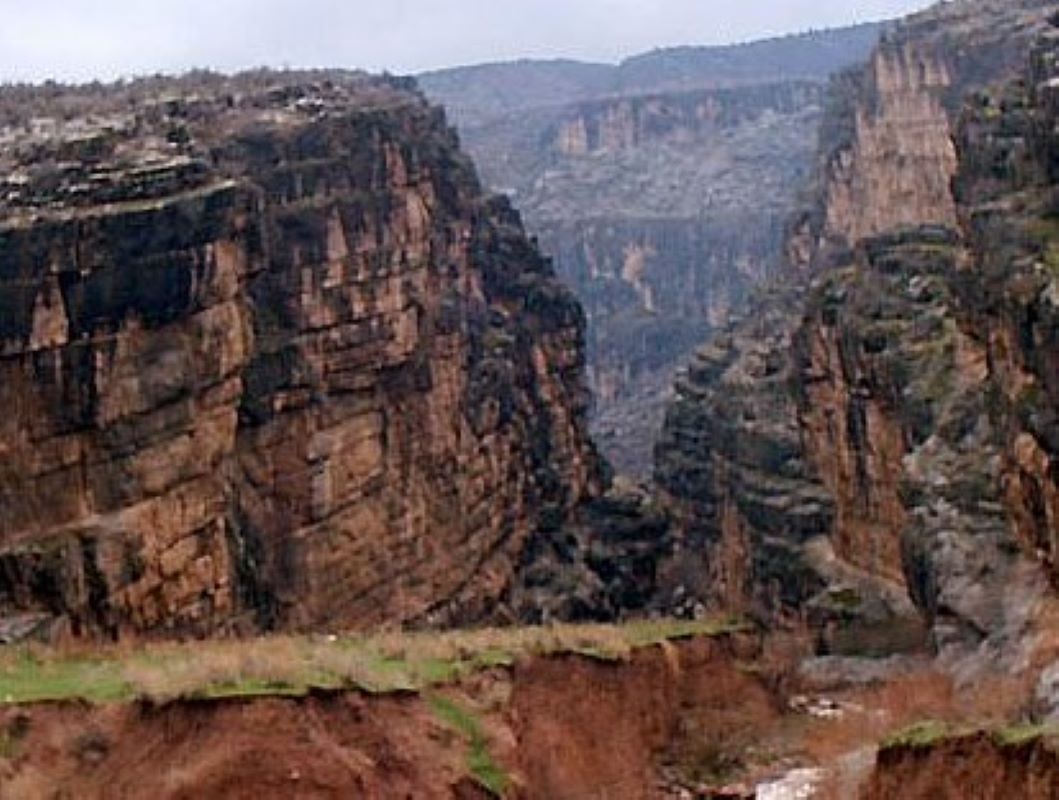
[0,619,751,704]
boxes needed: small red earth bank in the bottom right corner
[861,733,1059,800]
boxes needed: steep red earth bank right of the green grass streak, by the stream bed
[511,640,777,800]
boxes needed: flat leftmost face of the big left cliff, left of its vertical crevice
[0,183,264,629]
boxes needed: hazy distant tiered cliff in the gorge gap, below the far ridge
[533,85,822,476]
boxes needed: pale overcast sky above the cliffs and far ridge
[0,0,930,82]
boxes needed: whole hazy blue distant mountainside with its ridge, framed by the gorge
[424,25,878,476]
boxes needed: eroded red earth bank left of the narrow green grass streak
[0,693,472,800]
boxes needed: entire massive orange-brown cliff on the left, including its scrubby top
[0,73,598,635]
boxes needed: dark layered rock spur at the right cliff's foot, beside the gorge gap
[654,289,921,653]
